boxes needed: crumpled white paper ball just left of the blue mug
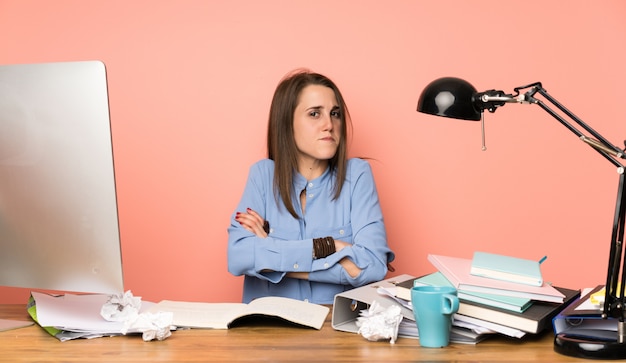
[356,300,403,344]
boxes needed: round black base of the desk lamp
[554,333,626,359]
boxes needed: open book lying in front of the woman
[149,296,330,330]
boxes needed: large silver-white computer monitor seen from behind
[0,61,124,293]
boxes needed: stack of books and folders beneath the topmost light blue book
[398,255,580,337]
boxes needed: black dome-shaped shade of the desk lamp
[417,77,481,121]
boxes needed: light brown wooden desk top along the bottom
[0,305,582,363]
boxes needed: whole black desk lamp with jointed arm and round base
[417,77,626,359]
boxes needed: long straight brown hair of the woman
[267,69,352,218]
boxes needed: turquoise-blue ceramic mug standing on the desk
[411,286,459,348]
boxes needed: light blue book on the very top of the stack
[470,251,543,286]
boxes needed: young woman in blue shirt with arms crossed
[228,70,394,304]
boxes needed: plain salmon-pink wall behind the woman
[0,0,626,303]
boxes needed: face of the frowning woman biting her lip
[293,85,341,166]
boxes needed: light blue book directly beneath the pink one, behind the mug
[413,271,533,313]
